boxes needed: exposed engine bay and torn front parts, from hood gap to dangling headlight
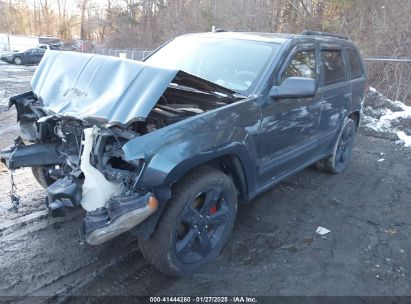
[0,53,238,245]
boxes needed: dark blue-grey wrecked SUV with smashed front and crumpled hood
[0,32,366,276]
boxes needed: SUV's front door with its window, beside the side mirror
[259,43,321,188]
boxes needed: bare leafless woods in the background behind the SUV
[0,0,411,102]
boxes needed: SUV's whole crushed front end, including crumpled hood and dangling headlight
[0,51,238,245]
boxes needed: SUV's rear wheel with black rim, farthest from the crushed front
[315,118,356,174]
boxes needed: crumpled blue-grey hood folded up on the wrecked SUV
[31,51,234,125]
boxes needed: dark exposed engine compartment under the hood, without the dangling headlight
[6,80,230,188]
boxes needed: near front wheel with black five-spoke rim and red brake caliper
[139,167,237,277]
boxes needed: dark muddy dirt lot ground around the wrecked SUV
[0,60,411,303]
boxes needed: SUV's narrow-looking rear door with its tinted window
[319,44,352,150]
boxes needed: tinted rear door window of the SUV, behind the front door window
[321,51,345,86]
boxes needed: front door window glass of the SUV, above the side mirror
[280,50,316,83]
